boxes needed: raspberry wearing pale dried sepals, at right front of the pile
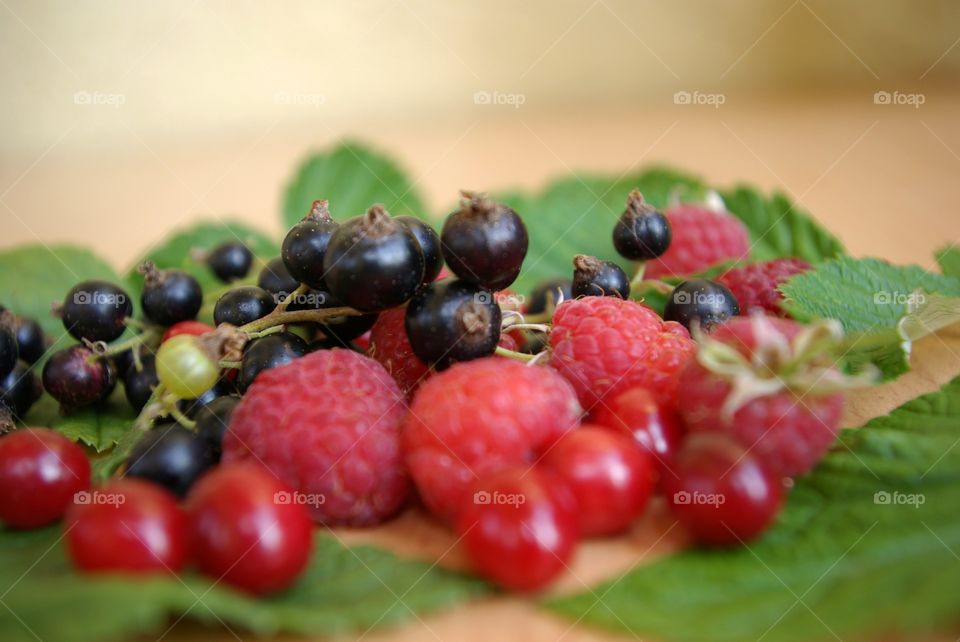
[680,316,843,477]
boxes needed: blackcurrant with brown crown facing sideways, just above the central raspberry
[404,279,501,370]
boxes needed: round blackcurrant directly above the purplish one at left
[61,281,133,342]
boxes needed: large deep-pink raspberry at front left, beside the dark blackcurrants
[223,349,408,526]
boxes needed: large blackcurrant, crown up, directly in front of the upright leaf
[323,205,424,312]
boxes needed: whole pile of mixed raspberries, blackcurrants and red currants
[0,182,872,593]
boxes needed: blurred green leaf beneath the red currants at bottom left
[0,528,488,642]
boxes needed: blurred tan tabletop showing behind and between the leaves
[0,92,960,642]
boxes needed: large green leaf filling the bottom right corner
[546,378,960,642]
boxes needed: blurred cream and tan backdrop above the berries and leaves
[0,0,960,268]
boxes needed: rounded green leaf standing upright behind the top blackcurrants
[283,142,426,229]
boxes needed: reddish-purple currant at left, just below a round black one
[43,345,117,408]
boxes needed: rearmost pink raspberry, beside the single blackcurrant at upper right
[645,203,750,278]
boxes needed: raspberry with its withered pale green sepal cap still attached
[680,316,846,477]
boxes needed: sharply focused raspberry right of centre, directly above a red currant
[550,297,696,410]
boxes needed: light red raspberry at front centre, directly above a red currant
[403,357,580,521]
